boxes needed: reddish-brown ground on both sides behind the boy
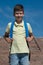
[0,38,43,65]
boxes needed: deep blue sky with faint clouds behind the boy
[0,0,43,37]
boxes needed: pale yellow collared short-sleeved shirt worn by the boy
[6,21,32,54]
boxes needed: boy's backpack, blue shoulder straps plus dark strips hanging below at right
[9,20,31,60]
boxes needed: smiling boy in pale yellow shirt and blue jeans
[4,4,33,65]
